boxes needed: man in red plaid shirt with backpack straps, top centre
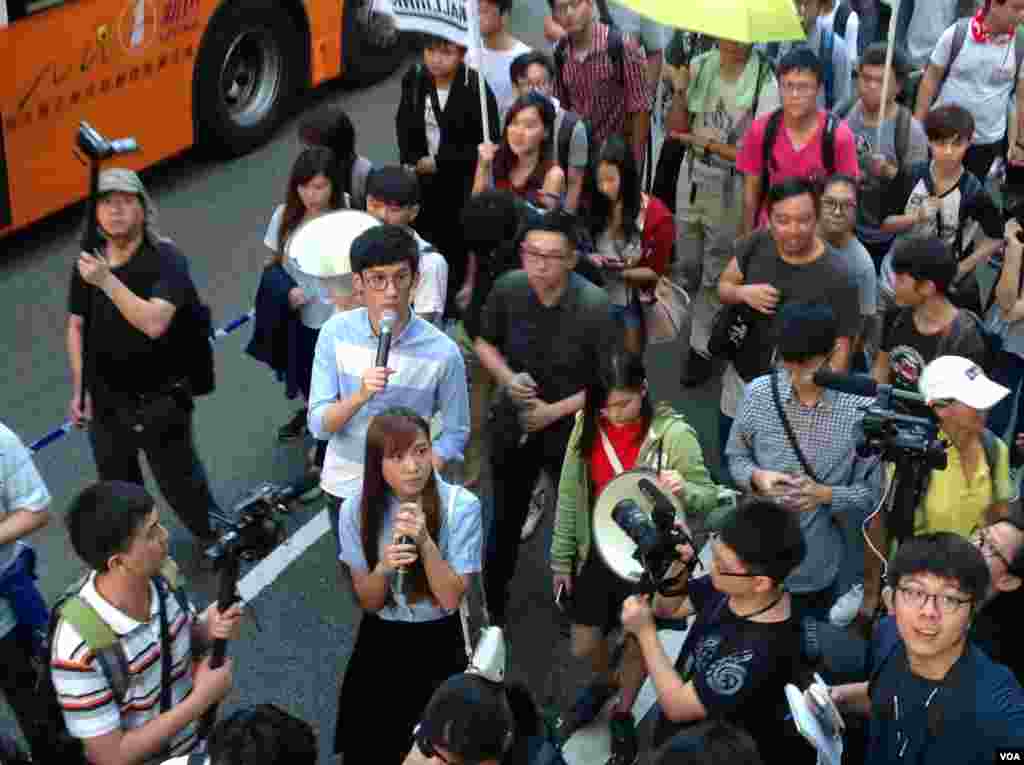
[548,0,650,164]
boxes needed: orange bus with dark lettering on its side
[0,0,406,236]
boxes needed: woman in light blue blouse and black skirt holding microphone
[335,408,482,765]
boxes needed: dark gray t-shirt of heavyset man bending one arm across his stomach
[733,228,861,381]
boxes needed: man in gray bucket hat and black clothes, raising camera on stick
[67,168,218,549]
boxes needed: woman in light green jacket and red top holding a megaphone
[551,349,718,762]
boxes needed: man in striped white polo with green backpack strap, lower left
[50,481,242,765]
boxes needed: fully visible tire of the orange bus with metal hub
[193,0,308,157]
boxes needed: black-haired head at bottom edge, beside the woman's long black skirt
[417,673,514,762]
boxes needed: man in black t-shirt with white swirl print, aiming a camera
[622,500,813,765]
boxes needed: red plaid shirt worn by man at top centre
[555,23,650,147]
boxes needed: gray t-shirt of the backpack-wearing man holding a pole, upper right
[846,101,928,244]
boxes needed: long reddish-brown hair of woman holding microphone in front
[359,407,441,603]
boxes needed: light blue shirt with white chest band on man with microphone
[309,308,469,498]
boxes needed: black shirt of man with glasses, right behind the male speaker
[480,270,621,403]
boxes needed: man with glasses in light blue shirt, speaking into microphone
[309,224,469,541]
